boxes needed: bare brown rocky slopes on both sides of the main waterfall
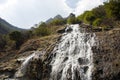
[0,24,120,80]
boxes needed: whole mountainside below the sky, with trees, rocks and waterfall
[0,0,120,80]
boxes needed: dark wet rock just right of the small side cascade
[16,57,43,80]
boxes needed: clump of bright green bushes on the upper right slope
[77,0,120,29]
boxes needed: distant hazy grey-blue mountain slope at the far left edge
[0,18,23,34]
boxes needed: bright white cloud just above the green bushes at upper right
[66,0,105,15]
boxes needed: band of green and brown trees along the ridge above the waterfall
[0,0,120,49]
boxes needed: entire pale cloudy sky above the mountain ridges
[0,0,105,29]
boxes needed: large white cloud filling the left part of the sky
[0,0,71,28]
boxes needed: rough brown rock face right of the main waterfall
[92,28,120,80]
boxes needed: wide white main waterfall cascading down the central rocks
[50,24,95,80]
